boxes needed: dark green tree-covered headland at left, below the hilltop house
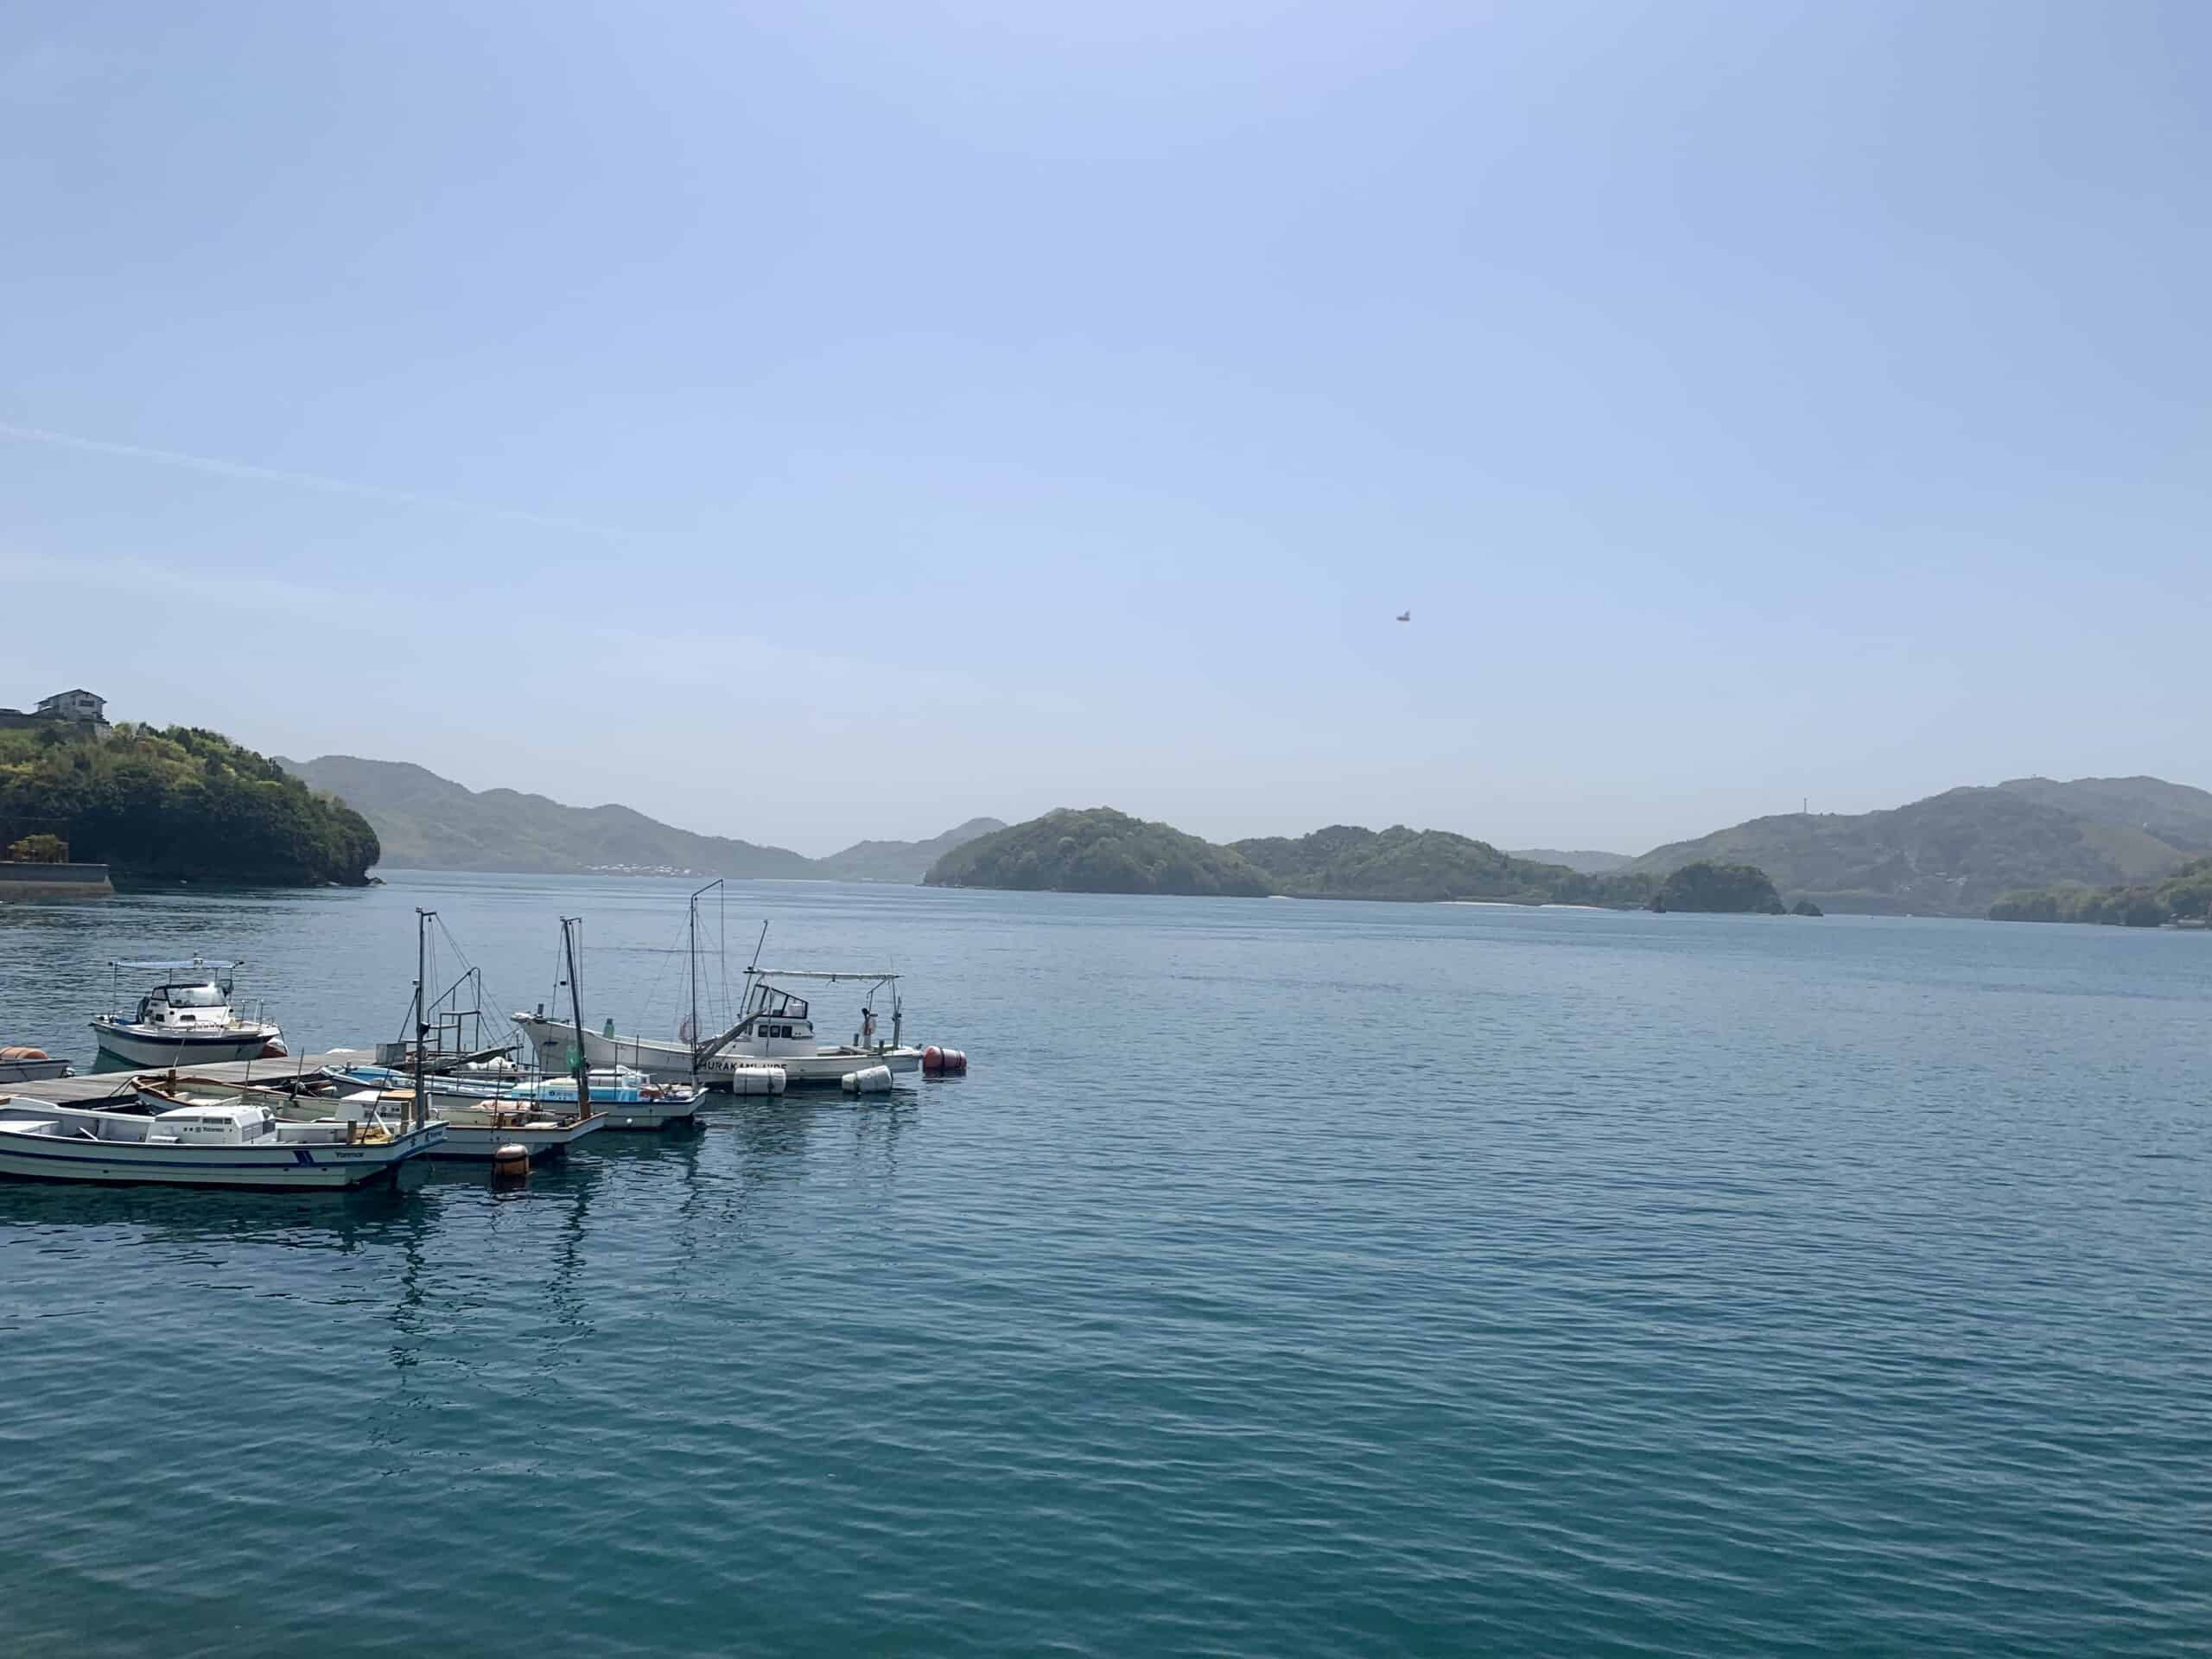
[0,726,378,885]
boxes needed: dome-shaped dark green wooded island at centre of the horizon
[927,807,1269,898]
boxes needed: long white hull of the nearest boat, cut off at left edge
[0,1123,442,1192]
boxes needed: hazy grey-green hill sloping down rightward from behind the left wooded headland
[276,754,817,876]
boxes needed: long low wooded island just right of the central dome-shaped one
[1232,823,1652,905]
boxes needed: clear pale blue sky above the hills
[0,0,2212,854]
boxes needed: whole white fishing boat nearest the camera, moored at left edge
[0,1097,445,1192]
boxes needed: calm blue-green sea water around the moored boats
[0,876,2212,1656]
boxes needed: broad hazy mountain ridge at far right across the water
[1630,779,2212,916]
